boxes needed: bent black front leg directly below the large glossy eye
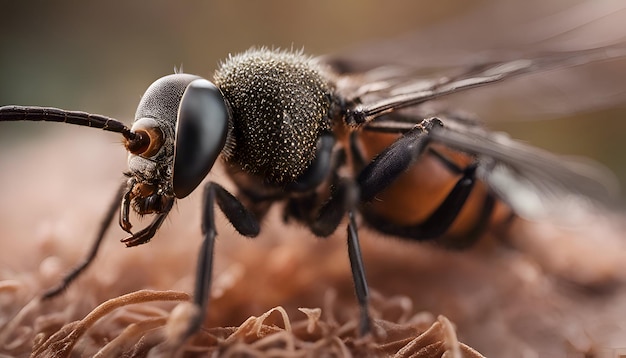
[185,182,259,338]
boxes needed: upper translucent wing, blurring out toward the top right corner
[324,0,626,121]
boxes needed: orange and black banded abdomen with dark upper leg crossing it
[351,115,511,249]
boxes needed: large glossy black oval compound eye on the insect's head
[172,79,229,198]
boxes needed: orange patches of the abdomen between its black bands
[357,131,511,246]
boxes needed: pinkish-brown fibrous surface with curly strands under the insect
[0,126,626,357]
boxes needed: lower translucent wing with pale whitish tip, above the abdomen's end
[432,118,619,218]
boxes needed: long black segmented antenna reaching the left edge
[0,106,150,152]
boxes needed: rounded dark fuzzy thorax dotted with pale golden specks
[214,48,331,184]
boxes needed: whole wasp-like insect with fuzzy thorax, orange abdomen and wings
[0,47,626,338]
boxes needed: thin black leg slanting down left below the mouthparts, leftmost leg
[42,183,126,299]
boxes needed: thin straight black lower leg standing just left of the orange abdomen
[348,211,371,336]
